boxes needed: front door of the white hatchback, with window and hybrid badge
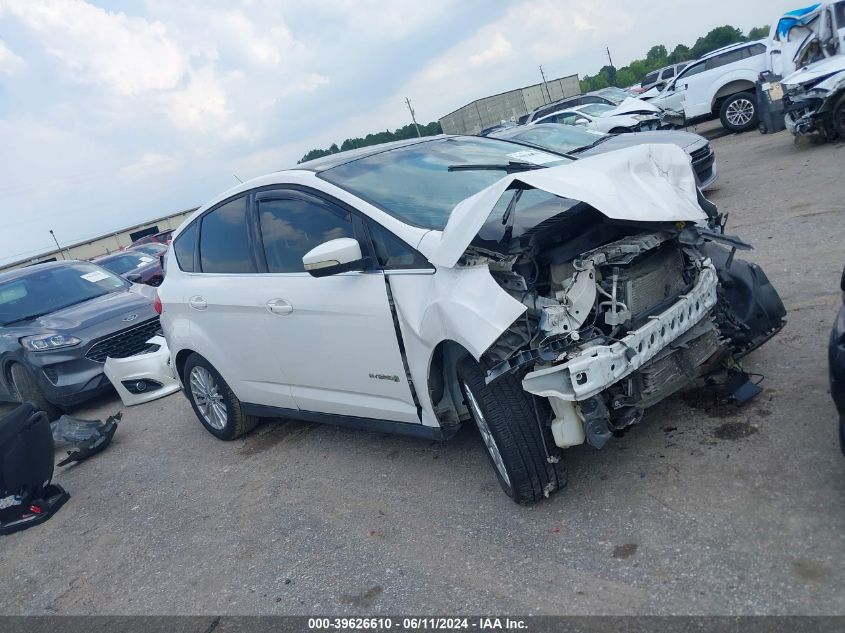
[254,189,420,424]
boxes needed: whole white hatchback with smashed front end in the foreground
[105,136,785,503]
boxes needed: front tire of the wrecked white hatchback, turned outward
[457,357,566,504]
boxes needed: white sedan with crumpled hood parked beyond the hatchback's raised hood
[531,99,661,134]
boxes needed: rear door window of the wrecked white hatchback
[200,197,255,273]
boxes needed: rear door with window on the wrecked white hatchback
[185,195,296,408]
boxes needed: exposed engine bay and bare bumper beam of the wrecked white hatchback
[464,190,786,448]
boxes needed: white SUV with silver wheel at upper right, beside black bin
[641,40,769,132]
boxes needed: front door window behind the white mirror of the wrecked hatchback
[258,198,355,273]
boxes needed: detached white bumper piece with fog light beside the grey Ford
[103,336,182,407]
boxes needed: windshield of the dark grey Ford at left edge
[0,262,129,325]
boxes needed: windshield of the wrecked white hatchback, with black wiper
[320,137,568,230]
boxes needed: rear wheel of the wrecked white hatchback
[182,353,258,441]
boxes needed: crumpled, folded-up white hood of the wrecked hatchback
[429,145,707,268]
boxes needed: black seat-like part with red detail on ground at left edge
[0,402,70,534]
